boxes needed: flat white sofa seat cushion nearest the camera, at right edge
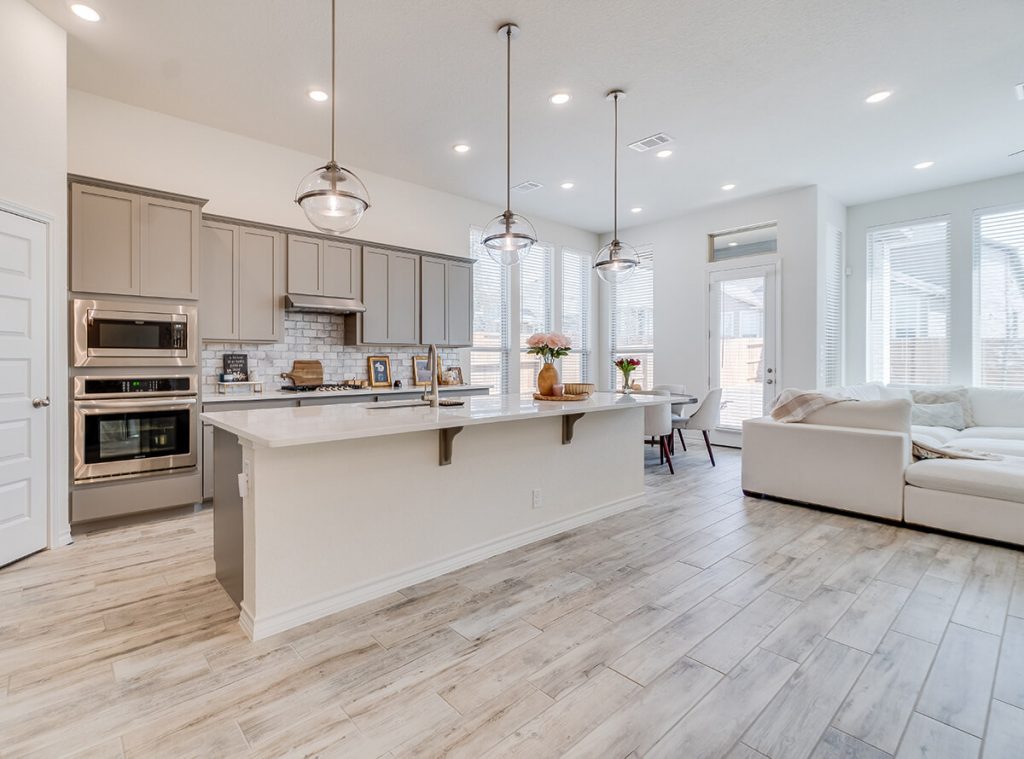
[905,458,1024,503]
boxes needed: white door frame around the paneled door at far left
[0,198,72,548]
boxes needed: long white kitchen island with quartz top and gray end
[203,393,671,640]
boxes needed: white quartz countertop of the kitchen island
[202,392,672,448]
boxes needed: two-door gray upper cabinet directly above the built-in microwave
[71,182,203,300]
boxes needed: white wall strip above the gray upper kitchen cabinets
[68,90,597,255]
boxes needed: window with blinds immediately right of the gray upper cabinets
[469,226,510,392]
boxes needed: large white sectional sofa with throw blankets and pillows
[742,384,1024,545]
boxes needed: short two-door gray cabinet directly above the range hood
[288,235,362,298]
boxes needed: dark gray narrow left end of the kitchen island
[213,428,243,606]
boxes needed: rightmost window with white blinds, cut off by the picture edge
[974,207,1024,387]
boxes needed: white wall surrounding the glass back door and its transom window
[598,186,821,393]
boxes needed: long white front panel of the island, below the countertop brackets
[242,408,644,639]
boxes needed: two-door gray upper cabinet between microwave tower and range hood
[200,220,285,342]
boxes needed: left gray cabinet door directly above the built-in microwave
[71,184,141,295]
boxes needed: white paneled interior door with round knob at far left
[0,210,49,566]
